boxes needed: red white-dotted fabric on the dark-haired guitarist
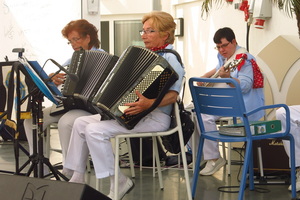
[235,53,264,88]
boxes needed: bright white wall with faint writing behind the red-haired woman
[0,0,100,106]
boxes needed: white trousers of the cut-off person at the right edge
[276,105,300,167]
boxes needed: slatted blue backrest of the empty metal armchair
[189,78,249,132]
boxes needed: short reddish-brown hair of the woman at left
[61,19,100,48]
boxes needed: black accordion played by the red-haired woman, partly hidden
[62,50,118,114]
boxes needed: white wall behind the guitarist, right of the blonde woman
[163,0,300,103]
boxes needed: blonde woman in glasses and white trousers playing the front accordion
[63,11,185,199]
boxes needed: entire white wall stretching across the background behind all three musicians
[0,0,300,108]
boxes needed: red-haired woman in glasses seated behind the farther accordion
[24,19,103,166]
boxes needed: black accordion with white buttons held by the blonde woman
[92,46,178,129]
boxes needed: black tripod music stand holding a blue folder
[15,56,68,180]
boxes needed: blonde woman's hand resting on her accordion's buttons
[124,91,154,115]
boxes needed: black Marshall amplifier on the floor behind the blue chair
[253,139,290,175]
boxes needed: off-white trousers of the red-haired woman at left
[24,107,92,163]
